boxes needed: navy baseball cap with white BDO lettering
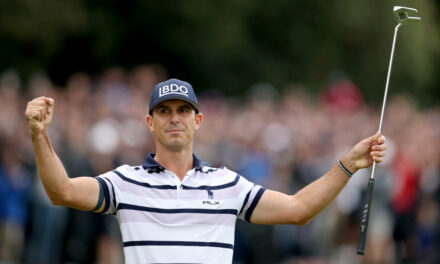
[149,79,199,115]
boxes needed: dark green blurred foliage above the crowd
[0,0,440,103]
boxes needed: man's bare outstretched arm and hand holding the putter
[250,133,386,225]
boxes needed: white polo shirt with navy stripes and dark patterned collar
[96,154,264,264]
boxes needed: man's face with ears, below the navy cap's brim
[147,100,203,151]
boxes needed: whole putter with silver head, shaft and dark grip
[357,6,421,255]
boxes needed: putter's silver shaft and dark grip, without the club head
[357,23,402,255]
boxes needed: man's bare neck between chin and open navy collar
[154,144,194,180]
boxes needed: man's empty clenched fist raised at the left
[24,96,55,135]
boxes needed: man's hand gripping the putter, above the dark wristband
[341,132,387,173]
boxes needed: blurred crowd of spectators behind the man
[0,65,440,264]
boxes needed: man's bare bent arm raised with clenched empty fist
[25,96,103,212]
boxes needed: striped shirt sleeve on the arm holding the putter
[238,176,266,222]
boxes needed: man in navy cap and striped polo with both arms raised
[25,79,386,263]
